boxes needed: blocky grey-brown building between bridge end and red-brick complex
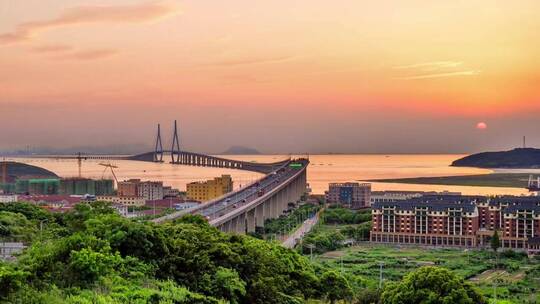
[325,183,371,209]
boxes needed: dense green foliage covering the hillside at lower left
[0,203,323,303]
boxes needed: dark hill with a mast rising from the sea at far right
[451,148,540,169]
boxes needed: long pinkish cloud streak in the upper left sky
[0,2,177,44]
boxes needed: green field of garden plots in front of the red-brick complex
[314,243,540,303]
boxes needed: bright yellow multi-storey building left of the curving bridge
[186,175,233,202]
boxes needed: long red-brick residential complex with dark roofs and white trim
[370,195,540,252]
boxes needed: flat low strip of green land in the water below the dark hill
[369,173,529,188]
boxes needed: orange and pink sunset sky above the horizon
[0,0,540,153]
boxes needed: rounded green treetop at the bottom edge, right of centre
[381,266,486,304]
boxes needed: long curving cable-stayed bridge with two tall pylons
[22,121,309,233]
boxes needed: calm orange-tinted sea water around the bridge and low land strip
[8,154,527,195]
